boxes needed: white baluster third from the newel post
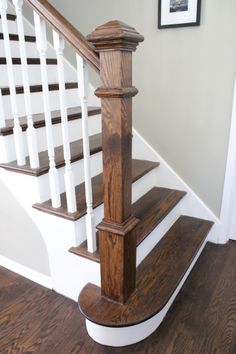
[34,13,61,208]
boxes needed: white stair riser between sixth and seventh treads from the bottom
[0,64,76,87]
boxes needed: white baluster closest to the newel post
[76,54,97,253]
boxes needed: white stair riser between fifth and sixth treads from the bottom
[2,89,79,119]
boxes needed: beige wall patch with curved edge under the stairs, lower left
[0,181,50,275]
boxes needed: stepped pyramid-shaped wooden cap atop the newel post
[87,20,144,52]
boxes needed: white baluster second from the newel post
[53,31,77,213]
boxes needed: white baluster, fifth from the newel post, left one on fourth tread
[0,0,26,166]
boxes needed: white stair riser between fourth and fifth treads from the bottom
[0,115,101,163]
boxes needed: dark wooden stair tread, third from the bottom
[33,160,159,221]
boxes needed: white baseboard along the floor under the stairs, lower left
[0,256,52,289]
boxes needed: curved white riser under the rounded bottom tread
[86,235,207,347]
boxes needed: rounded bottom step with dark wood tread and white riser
[79,217,212,347]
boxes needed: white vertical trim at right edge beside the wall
[219,80,236,243]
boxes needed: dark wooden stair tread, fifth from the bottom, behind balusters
[0,107,101,136]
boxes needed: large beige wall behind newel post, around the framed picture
[50,0,236,215]
